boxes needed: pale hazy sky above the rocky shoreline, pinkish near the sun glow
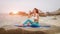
[0,0,60,13]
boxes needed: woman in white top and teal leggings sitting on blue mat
[24,8,40,27]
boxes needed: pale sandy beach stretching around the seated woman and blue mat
[0,14,60,34]
